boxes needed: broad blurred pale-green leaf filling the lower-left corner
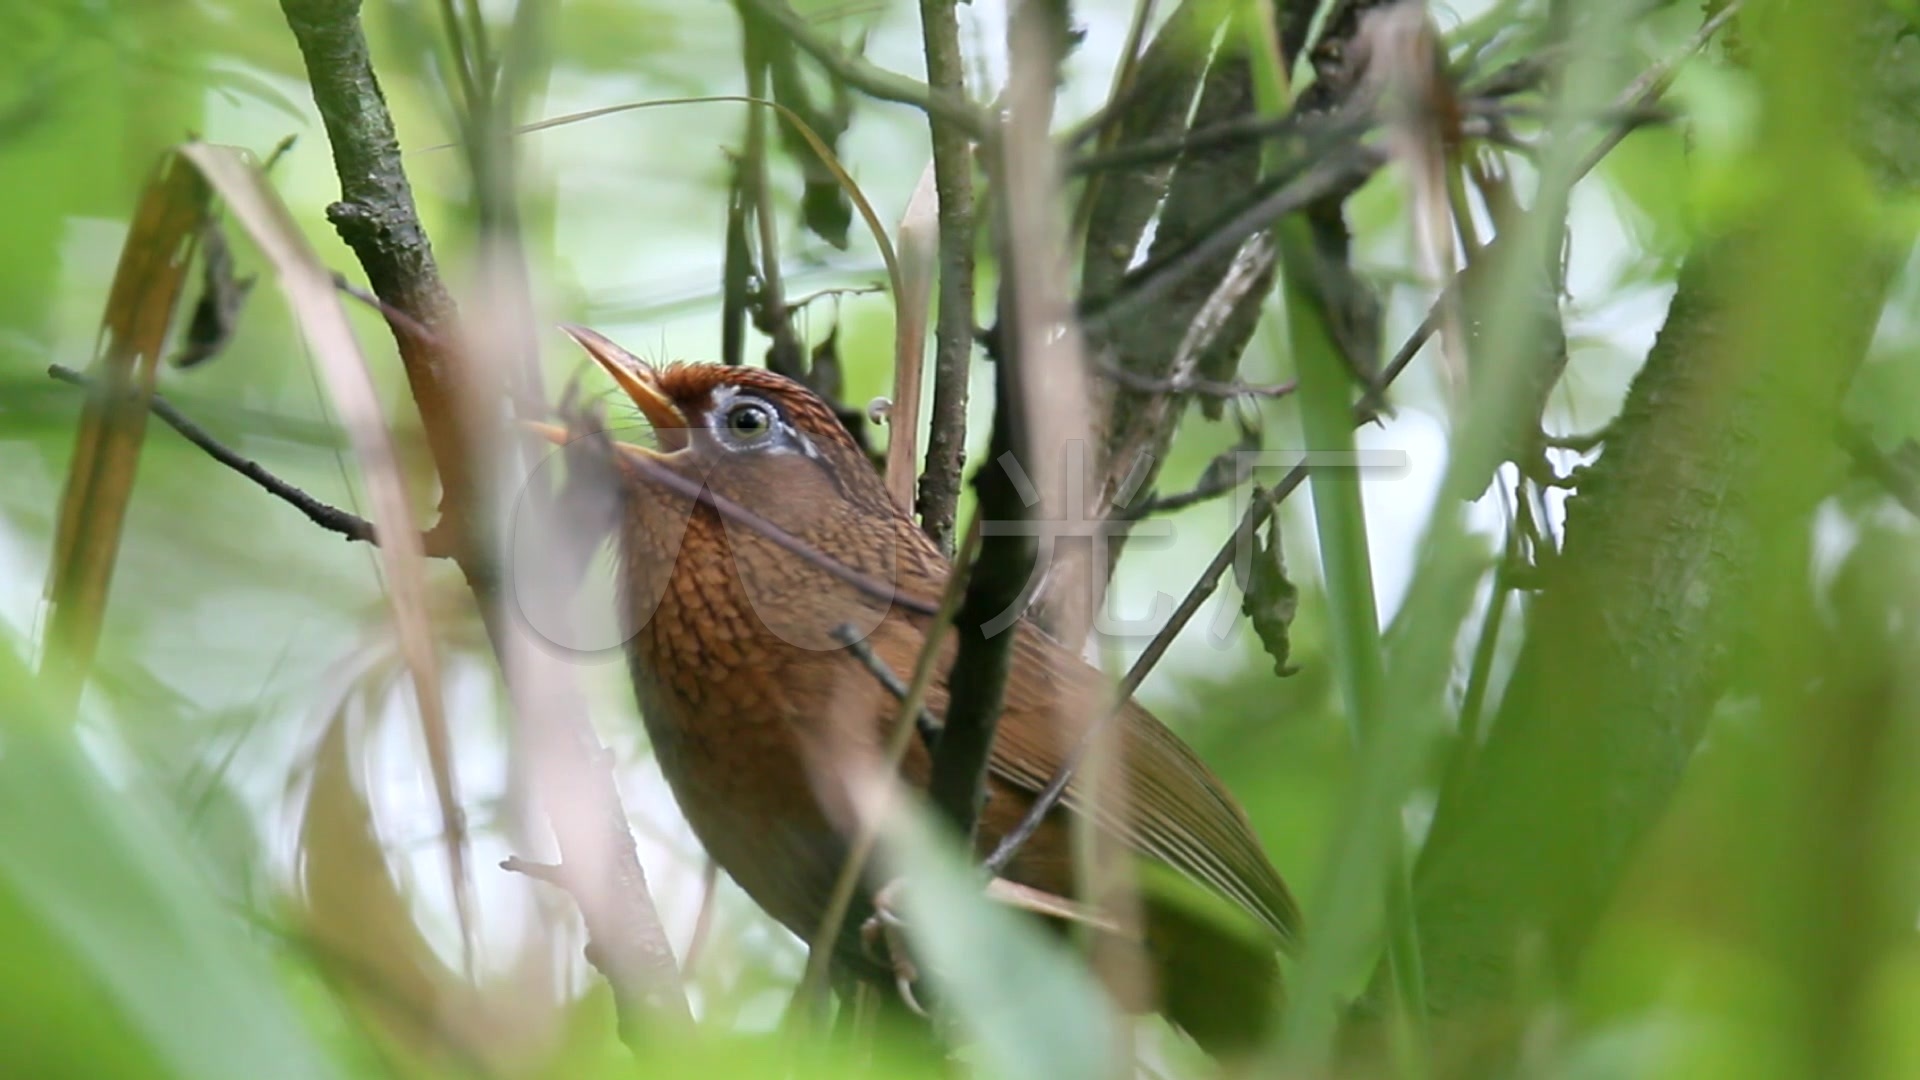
[0,642,334,1080]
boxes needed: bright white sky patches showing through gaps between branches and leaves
[0,0,1689,1006]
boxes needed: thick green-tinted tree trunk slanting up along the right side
[1415,4,1920,1011]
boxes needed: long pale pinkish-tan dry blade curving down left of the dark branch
[180,142,472,968]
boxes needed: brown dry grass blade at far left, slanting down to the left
[40,154,207,717]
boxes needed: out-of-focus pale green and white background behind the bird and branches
[0,0,1920,1076]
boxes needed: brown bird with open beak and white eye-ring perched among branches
[568,327,1300,1053]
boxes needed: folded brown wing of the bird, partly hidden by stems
[989,623,1300,944]
